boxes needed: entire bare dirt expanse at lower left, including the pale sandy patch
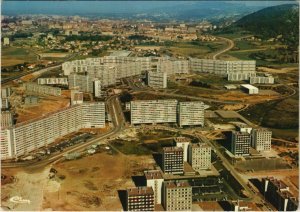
[1,152,154,211]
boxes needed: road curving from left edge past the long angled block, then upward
[1,96,125,168]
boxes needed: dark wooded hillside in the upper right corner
[232,4,299,48]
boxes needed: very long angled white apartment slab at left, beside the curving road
[1,102,105,159]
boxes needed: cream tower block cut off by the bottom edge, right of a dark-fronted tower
[163,182,192,211]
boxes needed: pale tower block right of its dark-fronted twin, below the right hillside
[251,128,272,152]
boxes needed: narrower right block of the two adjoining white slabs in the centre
[178,101,204,127]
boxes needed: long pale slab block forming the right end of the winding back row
[189,58,256,75]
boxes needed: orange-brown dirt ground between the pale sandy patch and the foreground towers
[43,153,154,211]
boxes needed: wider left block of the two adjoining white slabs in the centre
[130,99,177,124]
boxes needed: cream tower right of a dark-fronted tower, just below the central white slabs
[188,143,211,172]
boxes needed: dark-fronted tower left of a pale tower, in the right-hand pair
[229,131,251,156]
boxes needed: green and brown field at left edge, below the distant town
[1,47,38,66]
